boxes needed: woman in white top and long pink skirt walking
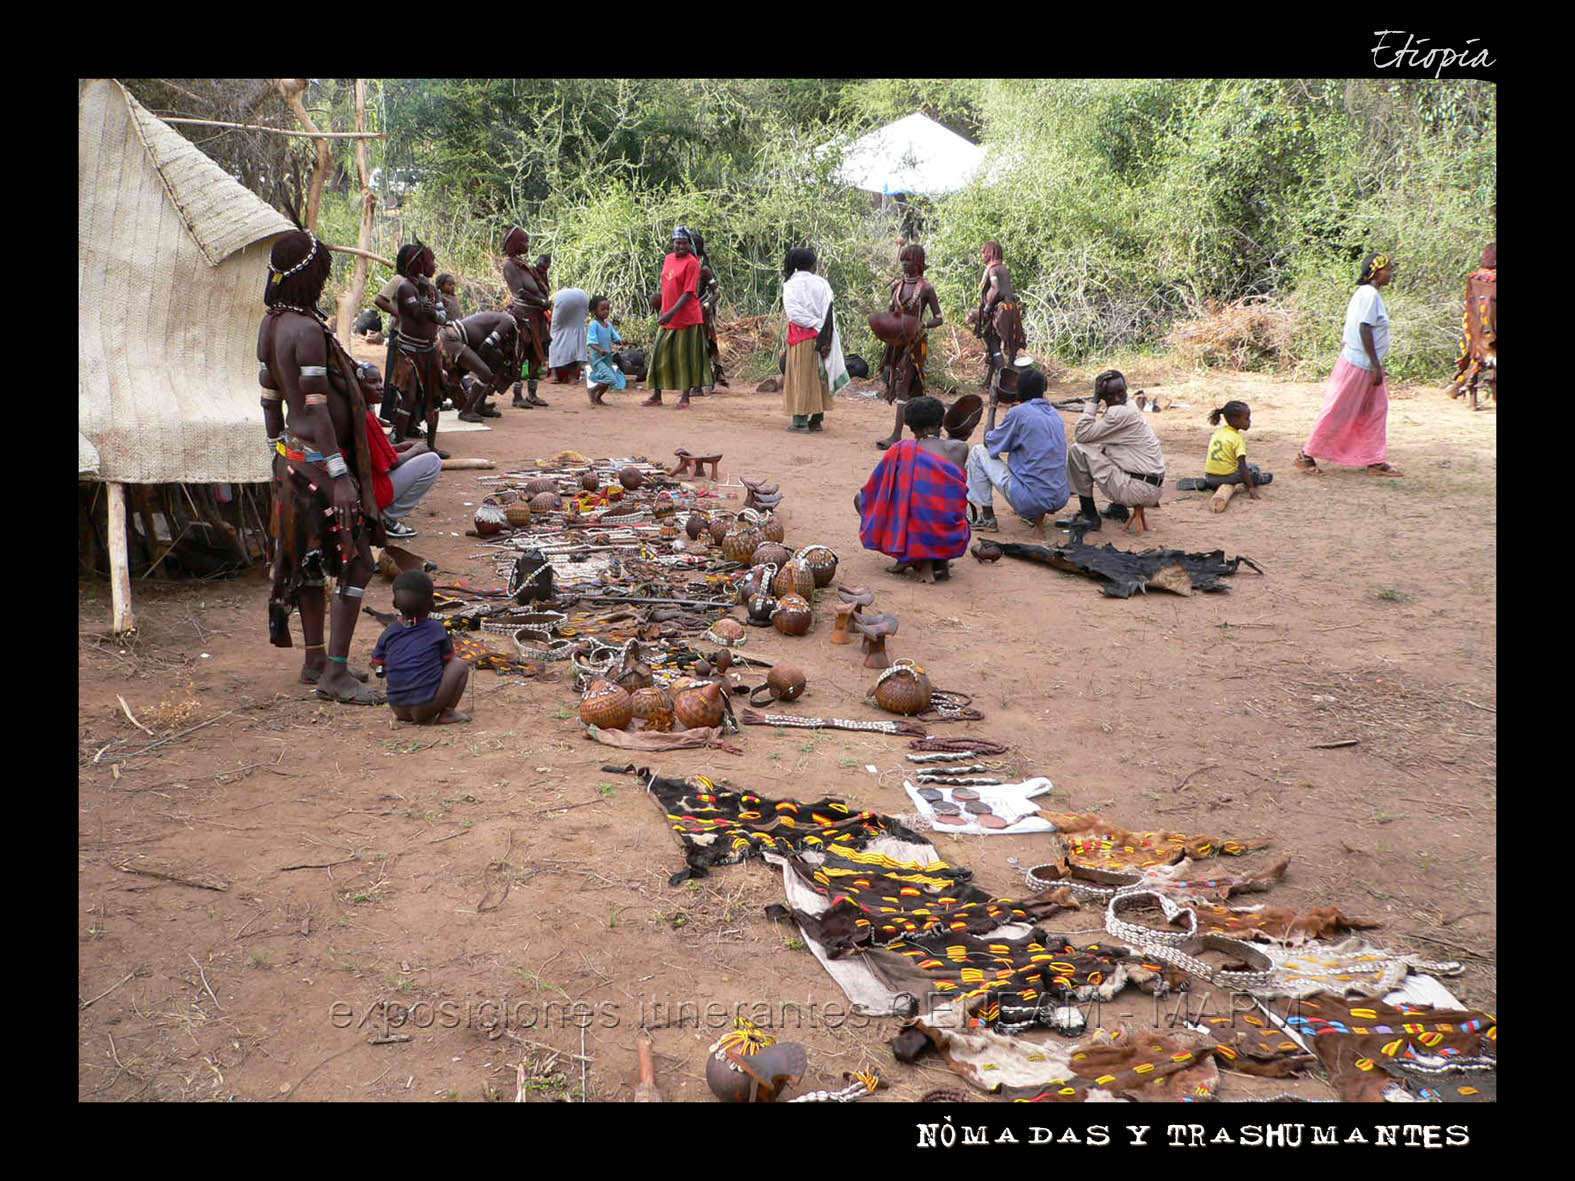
[1296,254,1402,476]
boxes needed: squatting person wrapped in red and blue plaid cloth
[854,397,969,583]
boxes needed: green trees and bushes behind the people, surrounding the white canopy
[181,79,1498,378]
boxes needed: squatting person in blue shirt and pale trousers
[967,368,1071,532]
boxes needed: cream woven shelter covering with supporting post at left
[77,79,293,631]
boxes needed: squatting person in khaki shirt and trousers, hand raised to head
[1057,368,1166,531]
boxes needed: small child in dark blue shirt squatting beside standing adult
[372,570,471,726]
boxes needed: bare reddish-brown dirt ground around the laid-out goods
[77,350,1496,1101]
